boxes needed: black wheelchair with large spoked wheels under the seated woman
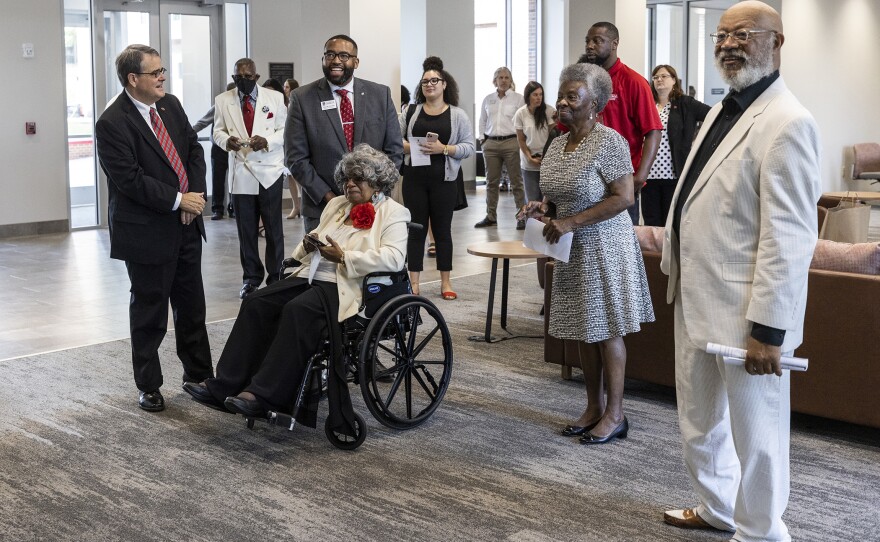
[235,258,453,450]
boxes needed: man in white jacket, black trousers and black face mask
[214,58,287,299]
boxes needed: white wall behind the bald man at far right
[780,0,880,191]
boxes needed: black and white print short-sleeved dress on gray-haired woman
[541,124,654,343]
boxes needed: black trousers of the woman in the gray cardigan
[402,172,461,271]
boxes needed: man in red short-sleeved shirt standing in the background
[578,22,663,224]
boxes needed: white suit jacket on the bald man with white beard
[661,77,820,352]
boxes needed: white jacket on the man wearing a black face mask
[214,87,287,195]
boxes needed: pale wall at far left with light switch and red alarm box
[0,0,69,233]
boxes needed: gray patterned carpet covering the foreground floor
[0,266,880,542]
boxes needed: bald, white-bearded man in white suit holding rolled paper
[661,1,820,542]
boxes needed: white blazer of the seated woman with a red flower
[292,196,410,322]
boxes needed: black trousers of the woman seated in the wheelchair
[205,278,339,413]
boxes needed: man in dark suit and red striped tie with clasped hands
[95,45,213,412]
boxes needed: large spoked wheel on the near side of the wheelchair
[358,295,453,429]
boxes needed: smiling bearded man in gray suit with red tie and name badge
[284,34,403,233]
